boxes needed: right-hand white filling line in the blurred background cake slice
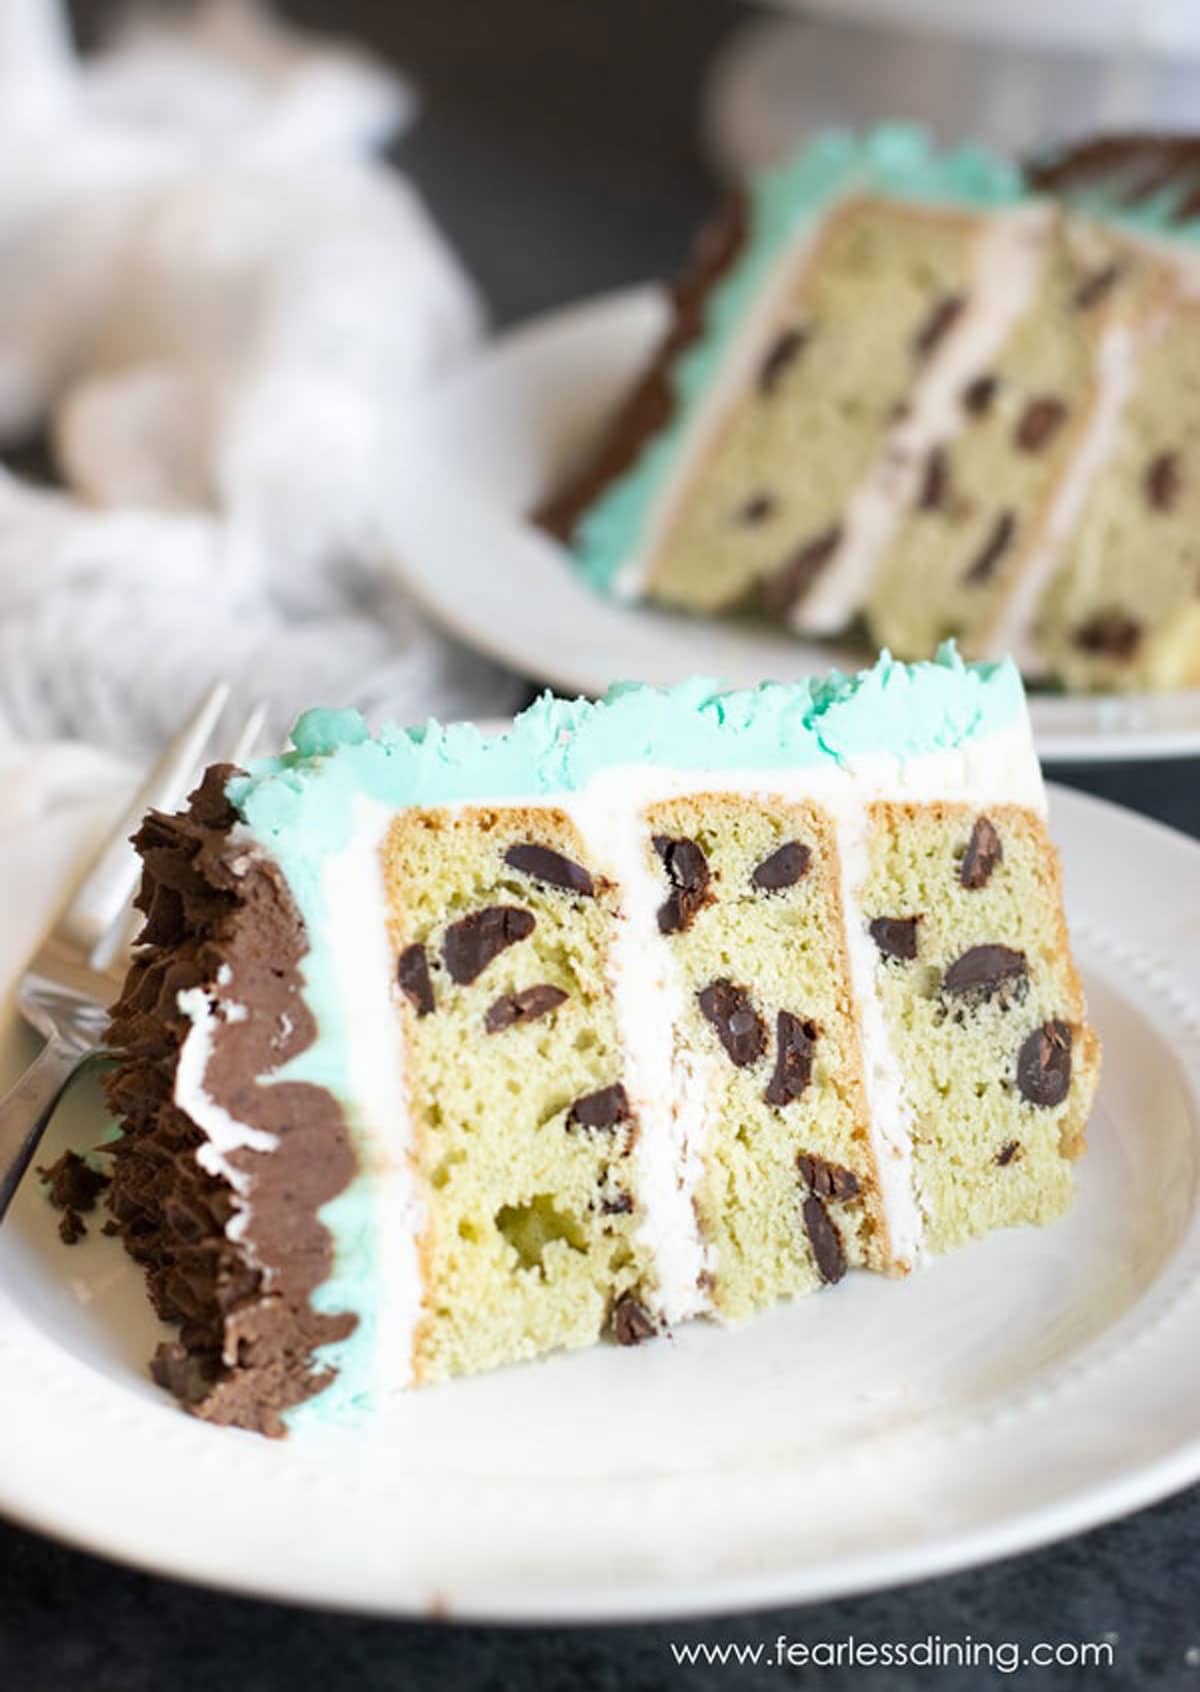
[987,316,1164,675]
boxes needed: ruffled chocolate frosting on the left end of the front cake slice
[108,766,355,1435]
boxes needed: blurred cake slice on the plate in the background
[540,125,1200,689]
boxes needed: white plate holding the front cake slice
[0,774,1200,1619]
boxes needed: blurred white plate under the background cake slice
[381,288,1200,760]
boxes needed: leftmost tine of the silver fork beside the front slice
[54,682,228,954]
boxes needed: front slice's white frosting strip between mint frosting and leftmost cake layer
[322,795,423,1399]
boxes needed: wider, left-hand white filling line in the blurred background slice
[790,205,1054,635]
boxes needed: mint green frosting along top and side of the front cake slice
[227,645,1024,1423]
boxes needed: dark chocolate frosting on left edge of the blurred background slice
[533,193,750,541]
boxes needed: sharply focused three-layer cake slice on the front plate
[108,651,1098,1433]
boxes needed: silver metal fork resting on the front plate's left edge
[0,682,264,1220]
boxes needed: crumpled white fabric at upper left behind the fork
[0,0,518,755]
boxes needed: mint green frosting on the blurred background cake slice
[572,124,1026,589]
